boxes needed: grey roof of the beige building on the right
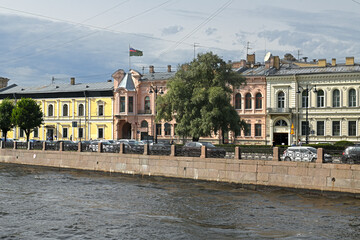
[270,64,360,76]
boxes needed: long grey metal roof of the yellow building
[0,82,114,94]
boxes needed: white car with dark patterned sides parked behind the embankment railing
[283,147,332,162]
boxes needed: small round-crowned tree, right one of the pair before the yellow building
[11,98,43,142]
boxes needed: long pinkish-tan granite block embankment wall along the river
[0,149,360,193]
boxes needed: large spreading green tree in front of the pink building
[157,52,245,141]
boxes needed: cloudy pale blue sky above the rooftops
[0,0,360,86]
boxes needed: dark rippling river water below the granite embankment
[0,164,360,239]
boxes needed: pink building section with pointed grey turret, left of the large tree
[112,66,175,140]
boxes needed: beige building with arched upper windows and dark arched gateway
[266,57,360,145]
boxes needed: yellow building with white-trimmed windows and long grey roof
[0,78,114,141]
